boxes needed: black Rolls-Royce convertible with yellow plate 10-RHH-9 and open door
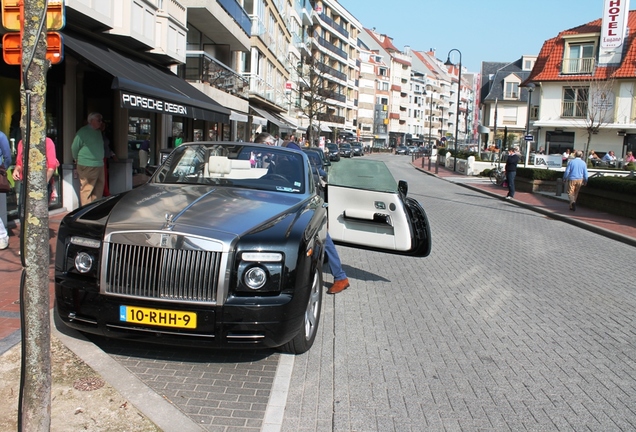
[55,141,431,354]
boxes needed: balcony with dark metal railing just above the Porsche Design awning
[185,51,249,99]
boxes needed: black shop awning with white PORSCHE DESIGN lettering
[63,33,230,123]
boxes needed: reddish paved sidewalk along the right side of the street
[412,159,636,246]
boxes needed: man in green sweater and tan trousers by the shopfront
[71,113,104,205]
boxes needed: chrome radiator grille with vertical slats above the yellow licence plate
[105,243,221,303]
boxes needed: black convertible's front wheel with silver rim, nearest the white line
[280,267,322,354]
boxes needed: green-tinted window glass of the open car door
[329,160,398,192]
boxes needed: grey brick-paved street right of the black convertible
[283,156,636,431]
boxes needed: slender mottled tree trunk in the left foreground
[18,0,51,431]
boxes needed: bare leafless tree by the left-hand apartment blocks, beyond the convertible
[297,56,341,145]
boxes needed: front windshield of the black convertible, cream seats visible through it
[151,142,311,193]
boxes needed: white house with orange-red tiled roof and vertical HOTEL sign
[524,8,636,158]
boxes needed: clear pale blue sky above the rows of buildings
[338,0,620,72]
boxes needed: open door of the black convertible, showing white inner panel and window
[327,160,431,257]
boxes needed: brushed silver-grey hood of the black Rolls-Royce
[106,183,305,237]
